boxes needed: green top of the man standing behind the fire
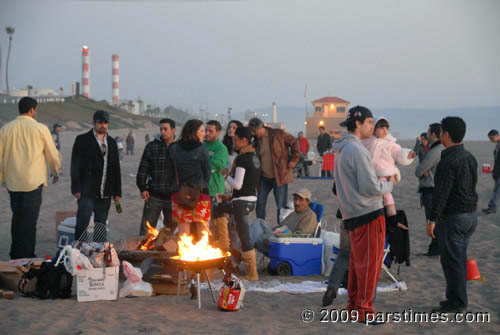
[203,140,228,197]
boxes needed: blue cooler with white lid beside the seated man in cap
[268,237,323,276]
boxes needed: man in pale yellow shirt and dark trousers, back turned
[0,97,61,259]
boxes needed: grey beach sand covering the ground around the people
[0,130,500,335]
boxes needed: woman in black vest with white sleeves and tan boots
[214,127,260,280]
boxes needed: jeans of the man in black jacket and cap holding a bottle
[75,198,111,242]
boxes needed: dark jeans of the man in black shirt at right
[439,213,477,307]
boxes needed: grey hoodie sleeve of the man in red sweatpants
[353,146,393,197]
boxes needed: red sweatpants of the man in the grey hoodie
[347,216,385,321]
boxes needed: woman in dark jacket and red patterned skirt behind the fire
[167,119,210,235]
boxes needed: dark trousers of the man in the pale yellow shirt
[9,185,43,259]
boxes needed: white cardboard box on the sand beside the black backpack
[76,266,120,302]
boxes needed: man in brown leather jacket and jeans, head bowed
[248,118,300,223]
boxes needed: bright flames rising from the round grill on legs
[177,230,229,261]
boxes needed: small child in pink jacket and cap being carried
[362,117,416,224]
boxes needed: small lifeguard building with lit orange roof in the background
[305,97,350,138]
